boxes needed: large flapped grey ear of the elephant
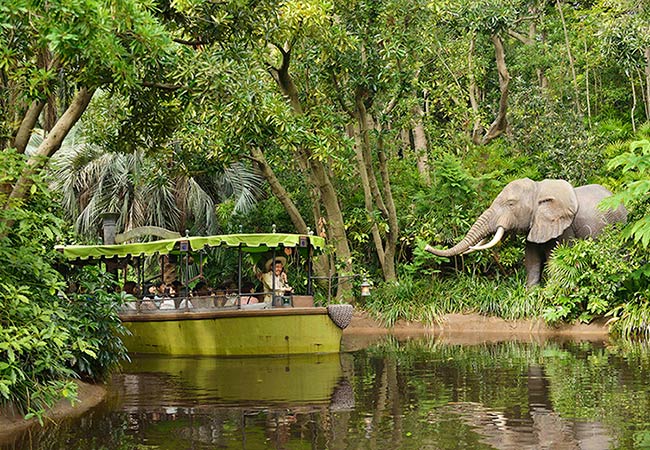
[527,180,578,244]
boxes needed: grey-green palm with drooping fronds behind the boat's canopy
[33,126,262,239]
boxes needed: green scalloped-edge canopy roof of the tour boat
[55,233,325,261]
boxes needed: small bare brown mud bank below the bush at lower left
[0,381,107,444]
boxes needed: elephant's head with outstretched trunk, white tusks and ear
[425,178,578,257]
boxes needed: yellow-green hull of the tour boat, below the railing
[121,308,342,356]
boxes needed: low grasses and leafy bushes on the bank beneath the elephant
[363,227,650,337]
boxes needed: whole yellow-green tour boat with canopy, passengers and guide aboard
[56,232,352,355]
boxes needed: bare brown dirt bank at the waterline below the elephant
[343,311,609,351]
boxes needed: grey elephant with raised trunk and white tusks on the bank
[425,178,627,288]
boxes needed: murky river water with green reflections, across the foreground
[1,338,650,450]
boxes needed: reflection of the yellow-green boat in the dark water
[114,354,354,448]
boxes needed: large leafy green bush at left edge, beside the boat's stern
[0,151,125,420]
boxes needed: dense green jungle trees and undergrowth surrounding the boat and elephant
[0,0,650,414]
